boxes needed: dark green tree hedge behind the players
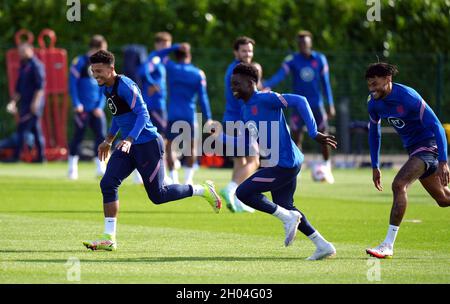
[0,0,450,150]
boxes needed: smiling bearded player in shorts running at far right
[366,63,450,258]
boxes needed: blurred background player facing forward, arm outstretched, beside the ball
[263,31,336,184]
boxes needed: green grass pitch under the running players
[0,163,450,284]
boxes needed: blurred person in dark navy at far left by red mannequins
[6,43,46,163]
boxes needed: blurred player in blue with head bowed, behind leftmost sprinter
[68,35,108,180]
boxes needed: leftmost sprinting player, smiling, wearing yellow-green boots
[83,51,221,250]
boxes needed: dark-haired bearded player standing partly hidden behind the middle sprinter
[220,36,259,212]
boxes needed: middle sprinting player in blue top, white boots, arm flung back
[221,63,336,260]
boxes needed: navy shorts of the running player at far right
[407,138,439,179]
